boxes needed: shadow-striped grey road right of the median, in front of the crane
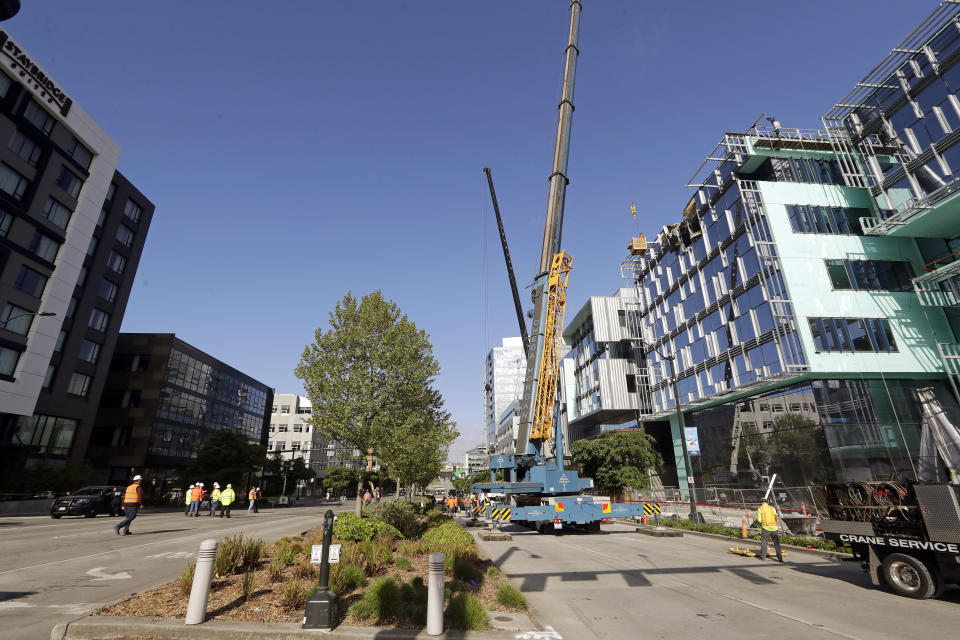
[472,524,960,640]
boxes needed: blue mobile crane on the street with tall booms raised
[470,0,643,532]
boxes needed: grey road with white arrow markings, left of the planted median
[0,505,351,640]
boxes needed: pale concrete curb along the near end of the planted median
[50,616,524,640]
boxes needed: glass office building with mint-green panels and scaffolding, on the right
[623,3,960,487]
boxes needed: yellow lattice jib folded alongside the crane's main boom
[529,251,573,440]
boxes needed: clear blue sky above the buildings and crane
[3,0,924,455]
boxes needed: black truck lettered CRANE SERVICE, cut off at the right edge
[821,482,960,599]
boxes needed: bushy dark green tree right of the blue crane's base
[571,431,663,496]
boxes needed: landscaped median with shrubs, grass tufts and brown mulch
[74,502,539,638]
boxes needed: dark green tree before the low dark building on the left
[183,429,267,495]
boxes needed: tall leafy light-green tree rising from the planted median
[295,291,460,515]
